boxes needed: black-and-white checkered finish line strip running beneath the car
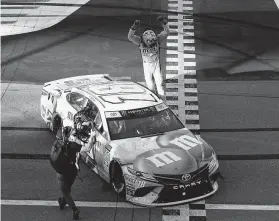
[163,0,206,221]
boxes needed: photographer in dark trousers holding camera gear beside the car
[54,112,96,220]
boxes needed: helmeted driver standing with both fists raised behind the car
[128,16,170,100]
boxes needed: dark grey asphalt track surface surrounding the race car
[1,0,279,221]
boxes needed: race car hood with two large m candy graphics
[113,129,213,174]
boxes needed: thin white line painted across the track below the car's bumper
[1,200,279,211]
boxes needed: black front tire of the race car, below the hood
[111,163,126,197]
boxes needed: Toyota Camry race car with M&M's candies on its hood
[40,74,220,206]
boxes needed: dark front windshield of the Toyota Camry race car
[107,109,184,140]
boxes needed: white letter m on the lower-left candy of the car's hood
[146,151,181,167]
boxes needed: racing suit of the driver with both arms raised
[128,23,170,98]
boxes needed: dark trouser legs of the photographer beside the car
[57,170,77,209]
